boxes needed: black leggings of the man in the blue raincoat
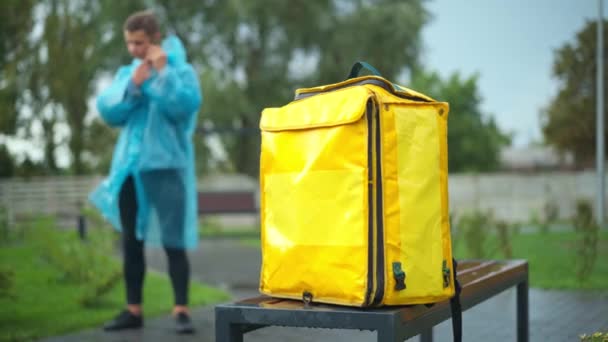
[118,176,190,305]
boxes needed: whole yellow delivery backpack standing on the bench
[260,62,456,307]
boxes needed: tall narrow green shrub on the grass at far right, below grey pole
[572,199,599,282]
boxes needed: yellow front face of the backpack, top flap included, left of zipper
[260,88,369,306]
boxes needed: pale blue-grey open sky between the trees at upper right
[423,0,608,146]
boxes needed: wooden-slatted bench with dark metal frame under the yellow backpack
[215,260,529,342]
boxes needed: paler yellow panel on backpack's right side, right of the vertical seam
[390,104,454,298]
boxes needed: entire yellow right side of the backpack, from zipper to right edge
[378,86,454,305]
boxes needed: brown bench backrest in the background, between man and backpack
[198,191,258,215]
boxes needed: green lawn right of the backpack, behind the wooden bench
[454,229,608,290]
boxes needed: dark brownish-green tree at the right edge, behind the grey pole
[541,22,608,166]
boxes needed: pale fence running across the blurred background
[0,172,596,222]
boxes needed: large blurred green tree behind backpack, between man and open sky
[157,0,429,176]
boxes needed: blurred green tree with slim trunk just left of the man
[43,0,146,174]
